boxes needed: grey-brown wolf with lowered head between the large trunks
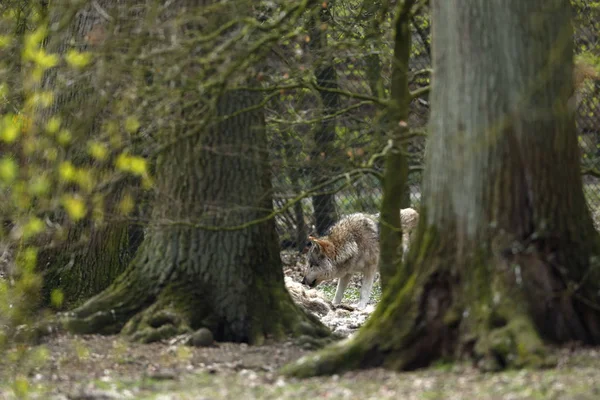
[302,208,419,310]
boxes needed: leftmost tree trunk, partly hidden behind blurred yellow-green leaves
[38,0,143,308]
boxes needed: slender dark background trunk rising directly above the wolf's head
[309,2,340,235]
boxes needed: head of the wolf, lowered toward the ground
[302,236,335,288]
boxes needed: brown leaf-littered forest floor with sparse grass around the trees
[0,252,600,400]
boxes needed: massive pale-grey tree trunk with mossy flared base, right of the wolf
[288,0,600,376]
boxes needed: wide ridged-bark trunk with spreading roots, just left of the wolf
[59,91,325,343]
